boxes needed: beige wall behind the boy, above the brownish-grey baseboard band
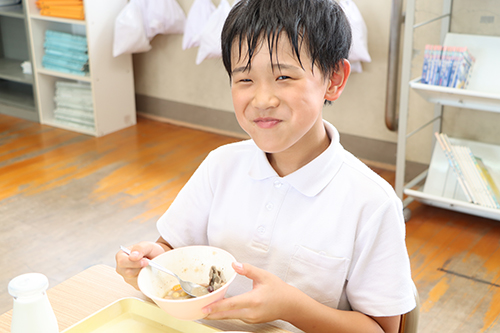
[134,0,500,162]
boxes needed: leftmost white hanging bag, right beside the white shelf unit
[113,0,151,57]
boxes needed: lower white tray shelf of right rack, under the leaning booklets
[404,138,500,220]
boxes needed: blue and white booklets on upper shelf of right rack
[421,45,476,89]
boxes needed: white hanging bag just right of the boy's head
[340,0,372,72]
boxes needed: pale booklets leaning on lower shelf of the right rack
[435,133,500,209]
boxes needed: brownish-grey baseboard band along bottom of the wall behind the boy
[135,94,422,174]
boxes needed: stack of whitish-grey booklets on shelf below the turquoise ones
[54,81,94,130]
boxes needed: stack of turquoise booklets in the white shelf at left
[42,30,89,76]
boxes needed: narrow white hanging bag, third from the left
[182,0,215,50]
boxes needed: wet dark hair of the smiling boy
[221,0,351,77]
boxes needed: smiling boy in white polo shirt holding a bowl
[117,0,415,333]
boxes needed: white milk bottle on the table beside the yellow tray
[9,273,59,333]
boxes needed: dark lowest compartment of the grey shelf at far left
[0,79,35,111]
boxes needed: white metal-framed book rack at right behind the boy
[396,0,500,220]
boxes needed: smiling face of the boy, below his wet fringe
[231,36,348,153]
